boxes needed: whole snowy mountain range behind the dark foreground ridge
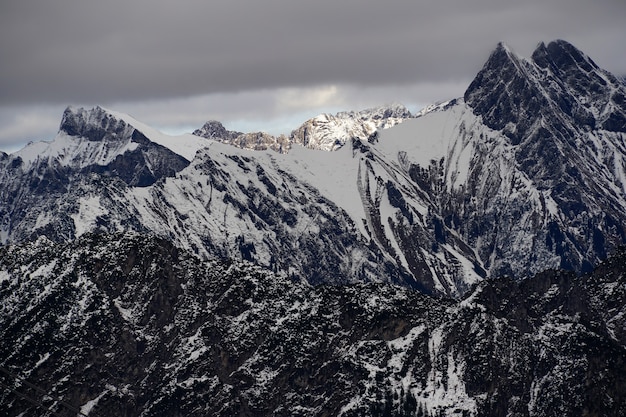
[0,41,626,297]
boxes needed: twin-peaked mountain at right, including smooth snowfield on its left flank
[375,41,626,277]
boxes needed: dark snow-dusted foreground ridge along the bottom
[0,234,626,417]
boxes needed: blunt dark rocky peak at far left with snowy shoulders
[12,106,195,186]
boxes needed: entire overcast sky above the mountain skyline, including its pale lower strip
[0,0,626,151]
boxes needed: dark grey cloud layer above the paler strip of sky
[0,0,626,104]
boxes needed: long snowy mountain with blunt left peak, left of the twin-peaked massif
[2,104,472,295]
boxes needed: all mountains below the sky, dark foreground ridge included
[0,40,626,417]
